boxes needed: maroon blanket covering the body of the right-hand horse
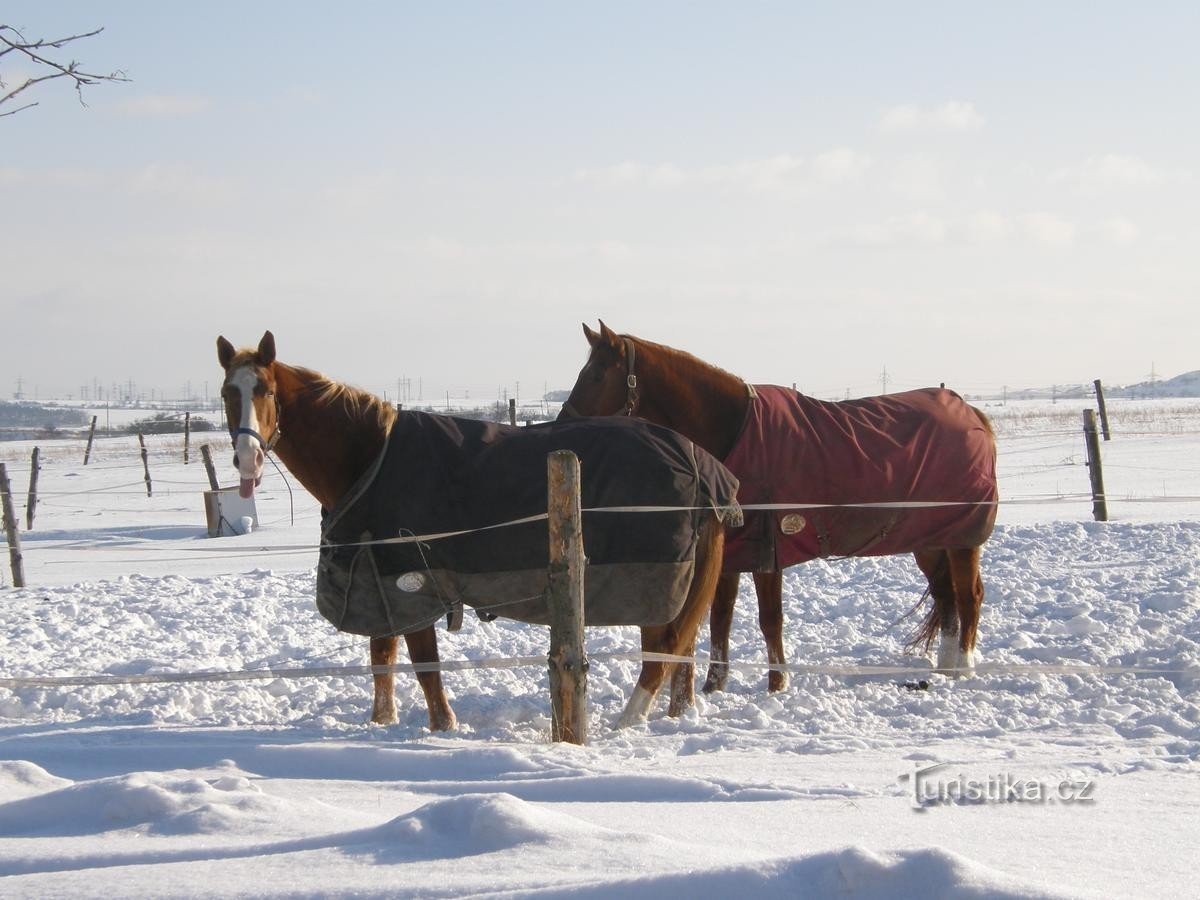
[724,385,998,572]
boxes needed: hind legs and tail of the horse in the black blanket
[617,525,725,728]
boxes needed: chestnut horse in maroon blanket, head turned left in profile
[559,322,997,692]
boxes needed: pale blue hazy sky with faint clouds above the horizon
[0,0,1200,403]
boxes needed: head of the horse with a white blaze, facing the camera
[217,331,281,498]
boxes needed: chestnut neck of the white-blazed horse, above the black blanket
[275,362,386,509]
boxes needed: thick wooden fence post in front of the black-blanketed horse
[546,450,588,744]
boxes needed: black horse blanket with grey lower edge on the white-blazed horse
[317,412,740,637]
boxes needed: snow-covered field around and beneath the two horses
[0,400,1200,898]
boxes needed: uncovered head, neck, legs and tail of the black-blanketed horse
[217,331,737,731]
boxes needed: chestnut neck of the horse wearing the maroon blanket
[635,340,750,460]
